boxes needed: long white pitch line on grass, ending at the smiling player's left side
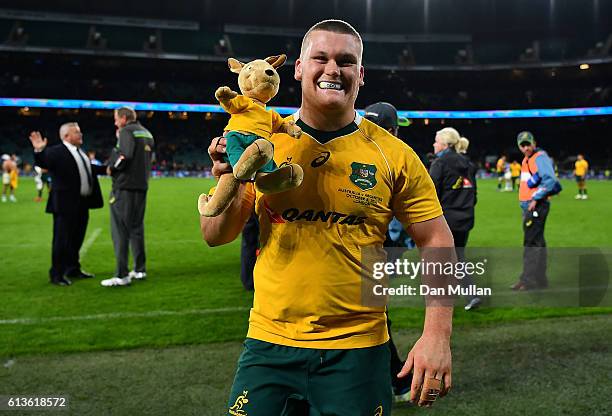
[0,306,251,325]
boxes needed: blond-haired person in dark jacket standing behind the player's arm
[429,127,481,311]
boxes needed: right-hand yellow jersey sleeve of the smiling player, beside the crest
[391,147,442,227]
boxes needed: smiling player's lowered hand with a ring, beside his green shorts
[397,333,452,407]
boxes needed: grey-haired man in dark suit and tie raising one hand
[30,123,106,286]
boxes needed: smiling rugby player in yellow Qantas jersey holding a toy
[200,20,453,416]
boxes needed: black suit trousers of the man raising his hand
[49,204,89,280]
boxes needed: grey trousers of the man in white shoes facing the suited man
[110,189,147,277]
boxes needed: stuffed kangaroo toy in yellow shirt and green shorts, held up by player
[198,55,304,217]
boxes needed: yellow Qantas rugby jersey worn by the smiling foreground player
[241,113,442,349]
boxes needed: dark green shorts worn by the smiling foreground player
[228,338,392,416]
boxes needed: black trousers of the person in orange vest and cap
[521,201,550,289]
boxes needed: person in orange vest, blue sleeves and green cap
[512,131,561,290]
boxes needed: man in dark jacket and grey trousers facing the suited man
[101,107,154,287]
